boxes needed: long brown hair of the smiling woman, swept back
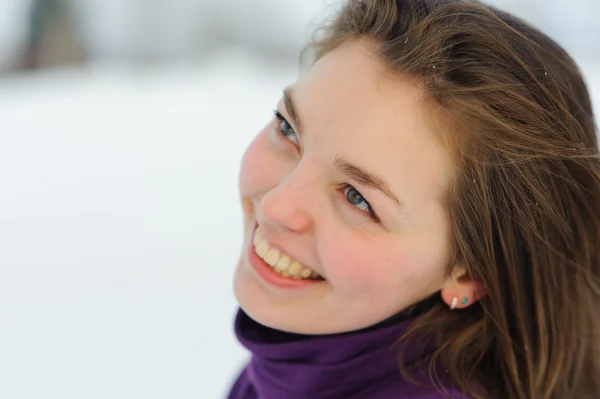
[307,0,600,399]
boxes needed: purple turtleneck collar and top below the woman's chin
[228,310,466,399]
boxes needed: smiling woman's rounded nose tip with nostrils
[259,173,314,233]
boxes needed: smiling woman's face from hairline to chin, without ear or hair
[235,42,453,334]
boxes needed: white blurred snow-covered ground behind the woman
[0,53,600,399]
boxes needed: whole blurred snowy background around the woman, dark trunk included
[0,0,600,399]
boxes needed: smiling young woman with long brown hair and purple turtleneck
[229,0,600,399]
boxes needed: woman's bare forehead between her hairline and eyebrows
[293,41,453,208]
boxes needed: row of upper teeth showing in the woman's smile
[254,231,321,280]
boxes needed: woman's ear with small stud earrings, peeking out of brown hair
[441,265,487,310]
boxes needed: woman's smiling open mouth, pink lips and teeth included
[248,226,325,287]
